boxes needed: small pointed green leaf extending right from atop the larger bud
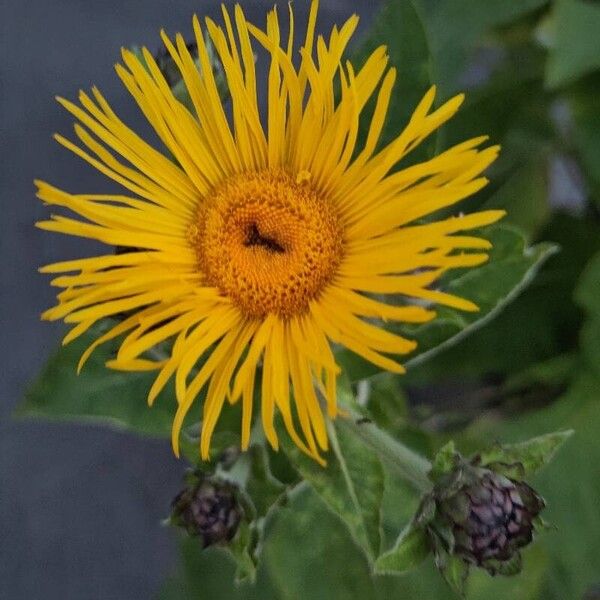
[479,429,574,479]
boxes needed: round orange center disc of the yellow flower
[190,170,343,317]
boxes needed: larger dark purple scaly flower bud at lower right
[437,468,544,574]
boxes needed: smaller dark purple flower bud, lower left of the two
[171,478,242,548]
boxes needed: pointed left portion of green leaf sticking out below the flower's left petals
[16,321,176,438]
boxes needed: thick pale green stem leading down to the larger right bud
[338,411,432,493]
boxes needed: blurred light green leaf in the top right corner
[546,0,600,88]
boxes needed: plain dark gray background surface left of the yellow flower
[0,0,379,600]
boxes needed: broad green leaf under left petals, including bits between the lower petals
[16,319,248,464]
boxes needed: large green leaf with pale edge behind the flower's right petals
[338,225,557,381]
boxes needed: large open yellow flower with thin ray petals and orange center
[37,0,503,462]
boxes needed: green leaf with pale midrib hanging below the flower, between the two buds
[281,425,384,561]
